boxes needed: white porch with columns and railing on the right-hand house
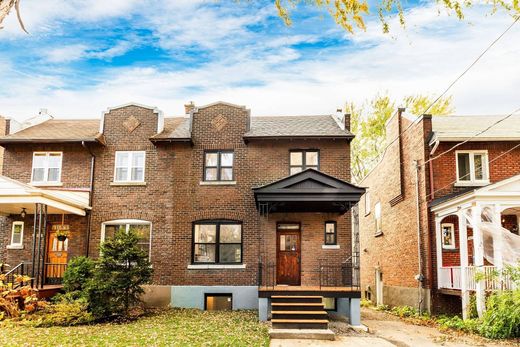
[431,175,520,318]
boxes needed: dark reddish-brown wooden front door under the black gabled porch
[276,224,301,286]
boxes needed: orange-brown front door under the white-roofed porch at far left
[45,230,69,284]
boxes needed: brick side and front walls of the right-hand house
[359,111,520,313]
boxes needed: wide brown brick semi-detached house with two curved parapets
[0,102,364,324]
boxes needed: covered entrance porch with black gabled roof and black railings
[254,169,364,325]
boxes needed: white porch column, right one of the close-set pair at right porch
[471,205,486,317]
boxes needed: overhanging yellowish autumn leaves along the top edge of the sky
[274,0,520,33]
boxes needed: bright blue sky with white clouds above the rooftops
[0,0,520,120]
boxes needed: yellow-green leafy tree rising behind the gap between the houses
[346,94,454,182]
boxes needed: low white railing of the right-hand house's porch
[439,266,514,291]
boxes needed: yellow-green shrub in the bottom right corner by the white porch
[479,289,520,339]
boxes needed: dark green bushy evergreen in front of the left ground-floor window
[87,228,152,317]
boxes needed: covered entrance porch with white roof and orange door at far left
[0,176,90,290]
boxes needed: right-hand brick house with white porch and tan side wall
[359,109,520,316]
